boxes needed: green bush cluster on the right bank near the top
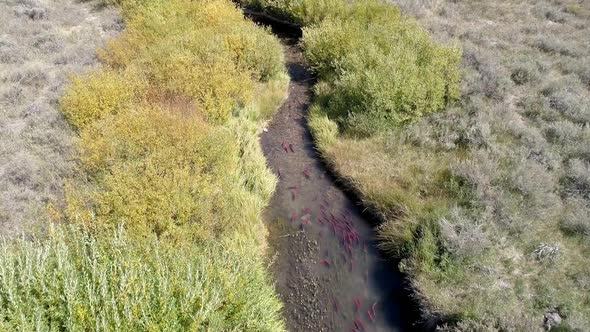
[246,0,461,136]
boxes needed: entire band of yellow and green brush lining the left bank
[0,0,287,331]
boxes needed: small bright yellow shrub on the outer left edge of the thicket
[60,70,145,128]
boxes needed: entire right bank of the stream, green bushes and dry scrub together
[245,0,590,331]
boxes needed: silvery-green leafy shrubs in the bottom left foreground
[0,226,282,331]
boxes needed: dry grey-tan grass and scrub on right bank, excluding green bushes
[311,0,590,331]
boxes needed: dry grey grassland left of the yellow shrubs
[0,0,121,234]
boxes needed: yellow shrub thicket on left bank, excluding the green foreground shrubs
[63,0,287,241]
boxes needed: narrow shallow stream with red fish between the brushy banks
[261,16,414,332]
